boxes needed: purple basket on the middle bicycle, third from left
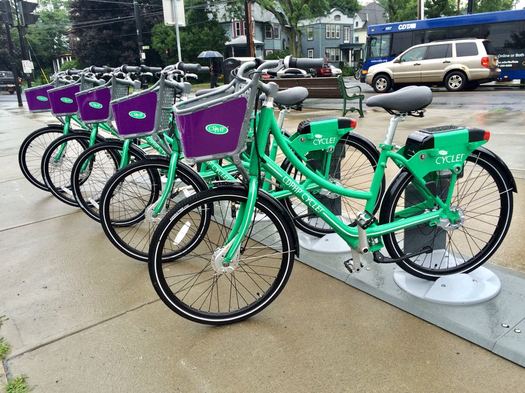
[75,86,111,123]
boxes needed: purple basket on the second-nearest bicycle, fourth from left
[111,91,158,138]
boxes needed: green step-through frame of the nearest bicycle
[223,106,486,265]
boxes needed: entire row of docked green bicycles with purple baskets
[19,56,516,325]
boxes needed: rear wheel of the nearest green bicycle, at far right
[380,151,513,280]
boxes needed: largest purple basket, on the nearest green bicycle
[175,97,248,159]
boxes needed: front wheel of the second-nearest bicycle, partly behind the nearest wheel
[100,157,207,262]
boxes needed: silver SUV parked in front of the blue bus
[366,39,501,93]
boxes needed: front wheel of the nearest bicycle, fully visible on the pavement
[149,187,295,325]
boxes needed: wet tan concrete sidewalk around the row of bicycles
[0,102,525,393]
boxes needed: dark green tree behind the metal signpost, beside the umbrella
[151,0,227,64]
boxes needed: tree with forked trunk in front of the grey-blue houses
[256,0,330,56]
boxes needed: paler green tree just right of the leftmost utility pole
[26,0,70,68]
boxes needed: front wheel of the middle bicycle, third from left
[71,140,145,222]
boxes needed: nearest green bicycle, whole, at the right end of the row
[145,57,516,324]
